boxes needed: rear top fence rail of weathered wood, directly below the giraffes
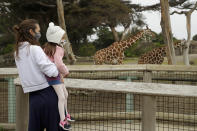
[0,64,197,76]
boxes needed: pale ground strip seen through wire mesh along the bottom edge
[69,121,197,131]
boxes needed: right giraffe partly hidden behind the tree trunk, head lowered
[138,40,186,64]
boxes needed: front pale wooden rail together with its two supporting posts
[15,75,197,131]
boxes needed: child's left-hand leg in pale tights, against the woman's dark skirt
[53,84,65,121]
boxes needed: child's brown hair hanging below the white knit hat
[43,42,58,57]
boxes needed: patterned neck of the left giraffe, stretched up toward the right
[119,31,144,50]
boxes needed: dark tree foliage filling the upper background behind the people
[0,0,189,54]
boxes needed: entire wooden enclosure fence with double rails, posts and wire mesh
[0,65,197,131]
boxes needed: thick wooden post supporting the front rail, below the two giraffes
[142,71,156,131]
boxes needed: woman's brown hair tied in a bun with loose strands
[13,19,40,58]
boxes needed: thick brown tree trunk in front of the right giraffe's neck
[160,0,176,65]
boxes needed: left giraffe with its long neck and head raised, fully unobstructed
[93,28,155,65]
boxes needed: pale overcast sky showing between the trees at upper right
[127,0,197,39]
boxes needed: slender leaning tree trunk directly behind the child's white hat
[57,0,76,64]
